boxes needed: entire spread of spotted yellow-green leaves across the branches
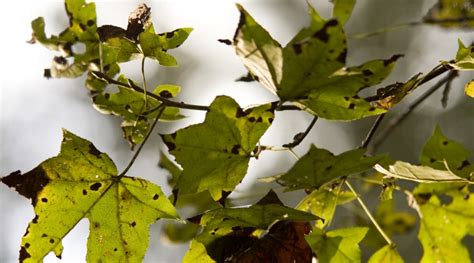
[1,0,474,262]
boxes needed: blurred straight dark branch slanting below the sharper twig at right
[369,71,458,152]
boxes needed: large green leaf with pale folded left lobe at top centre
[233,4,400,120]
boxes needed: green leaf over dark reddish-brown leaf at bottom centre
[184,191,318,262]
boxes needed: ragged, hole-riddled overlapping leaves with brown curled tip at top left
[30,0,192,92]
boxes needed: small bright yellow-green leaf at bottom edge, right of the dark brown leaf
[306,227,369,263]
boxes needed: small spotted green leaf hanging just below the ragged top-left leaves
[92,75,183,146]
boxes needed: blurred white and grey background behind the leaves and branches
[0,0,474,262]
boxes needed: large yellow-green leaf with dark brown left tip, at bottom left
[1,130,178,262]
